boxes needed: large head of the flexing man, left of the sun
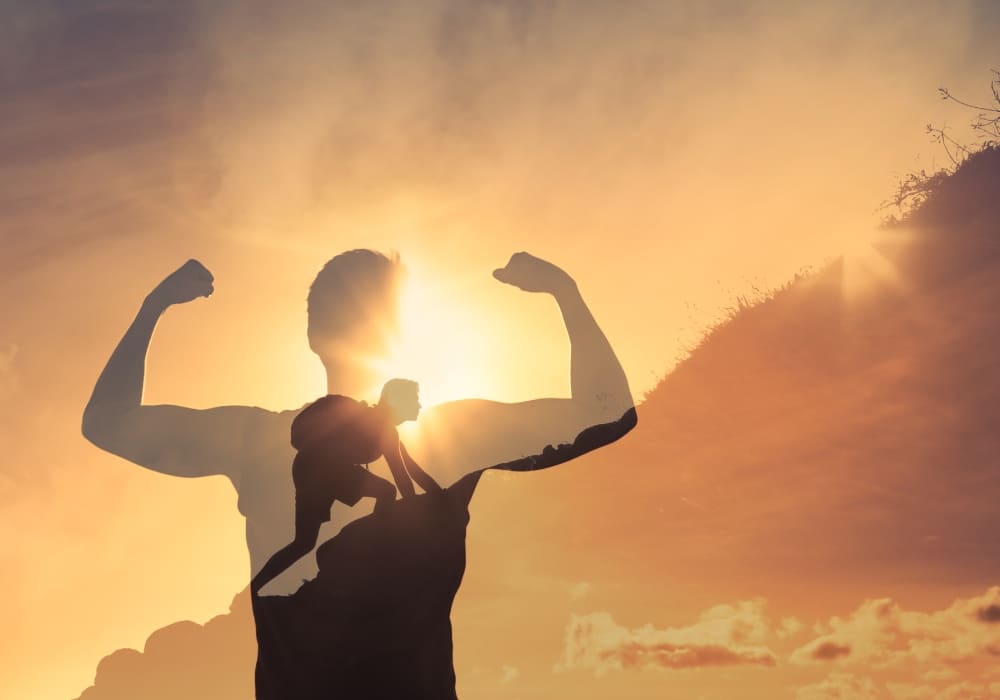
[307,249,404,368]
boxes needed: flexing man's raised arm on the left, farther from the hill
[83,260,270,476]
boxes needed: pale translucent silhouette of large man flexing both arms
[83,250,633,594]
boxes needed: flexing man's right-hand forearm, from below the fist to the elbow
[553,282,634,419]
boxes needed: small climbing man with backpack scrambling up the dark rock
[250,379,441,593]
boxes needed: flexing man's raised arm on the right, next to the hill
[412,253,635,484]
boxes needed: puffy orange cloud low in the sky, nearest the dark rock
[556,600,777,674]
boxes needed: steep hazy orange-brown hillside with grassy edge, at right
[488,149,1000,583]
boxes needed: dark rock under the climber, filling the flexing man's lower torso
[253,494,469,700]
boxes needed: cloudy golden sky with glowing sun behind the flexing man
[0,0,1000,700]
